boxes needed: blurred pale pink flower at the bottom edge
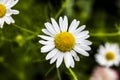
[90,67,119,80]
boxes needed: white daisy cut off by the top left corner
[0,0,19,28]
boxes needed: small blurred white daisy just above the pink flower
[95,43,120,67]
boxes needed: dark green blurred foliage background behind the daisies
[0,0,120,80]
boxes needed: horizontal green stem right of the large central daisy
[90,32,120,37]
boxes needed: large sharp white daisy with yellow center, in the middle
[39,16,92,68]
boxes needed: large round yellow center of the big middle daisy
[54,32,75,52]
